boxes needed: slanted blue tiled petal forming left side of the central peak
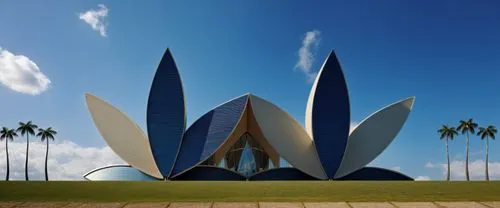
[171,95,248,177]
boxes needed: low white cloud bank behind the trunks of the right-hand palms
[426,160,500,180]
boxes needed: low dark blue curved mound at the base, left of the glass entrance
[172,166,246,181]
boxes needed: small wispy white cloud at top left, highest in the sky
[78,4,109,37]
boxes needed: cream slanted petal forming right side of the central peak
[250,95,328,179]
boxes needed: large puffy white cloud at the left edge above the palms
[0,47,50,95]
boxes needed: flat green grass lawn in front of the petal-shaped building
[0,181,500,202]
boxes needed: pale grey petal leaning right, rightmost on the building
[335,97,415,178]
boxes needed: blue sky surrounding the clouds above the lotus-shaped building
[0,0,500,179]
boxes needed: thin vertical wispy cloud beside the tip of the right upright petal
[295,30,321,82]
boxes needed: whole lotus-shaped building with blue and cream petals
[84,49,414,180]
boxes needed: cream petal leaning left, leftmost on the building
[85,93,163,178]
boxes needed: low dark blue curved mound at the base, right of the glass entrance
[248,168,317,181]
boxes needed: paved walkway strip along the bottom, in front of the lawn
[0,202,500,208]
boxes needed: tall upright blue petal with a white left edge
[306,51,351,178]
